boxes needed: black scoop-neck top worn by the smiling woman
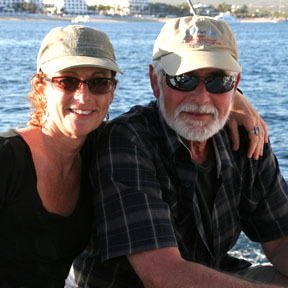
[0,130,97,288]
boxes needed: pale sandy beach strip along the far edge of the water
[0,14,287,24]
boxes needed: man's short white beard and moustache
[159,87,232,141]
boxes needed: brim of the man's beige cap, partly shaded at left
[161,50,242,76]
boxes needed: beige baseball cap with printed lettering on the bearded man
[152,16,242,76]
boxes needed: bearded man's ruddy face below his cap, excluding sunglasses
[159,69,236,141]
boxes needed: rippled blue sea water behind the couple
[0,20,288,263]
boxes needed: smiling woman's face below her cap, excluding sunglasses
[44,67,116,138]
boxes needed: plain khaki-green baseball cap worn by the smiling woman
[37,25,123,74]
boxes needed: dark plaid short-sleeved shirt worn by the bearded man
[68,102,288,288]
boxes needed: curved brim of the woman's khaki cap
[38,56,124,74]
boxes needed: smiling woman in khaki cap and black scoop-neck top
[0,26,122,288]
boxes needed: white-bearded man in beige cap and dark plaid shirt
[68,16,288,288]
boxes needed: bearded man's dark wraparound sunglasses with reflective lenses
[165,73,236,94]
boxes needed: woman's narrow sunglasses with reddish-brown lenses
[45,76,117,94]
